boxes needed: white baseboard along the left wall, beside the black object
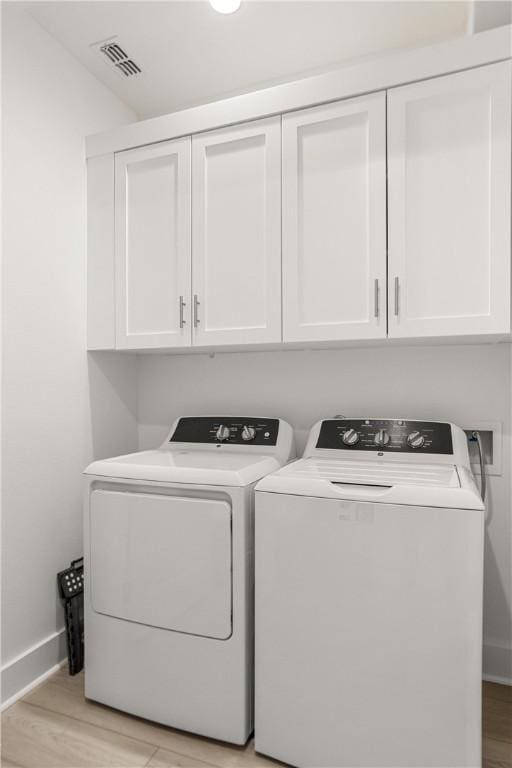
[1,629,67,710]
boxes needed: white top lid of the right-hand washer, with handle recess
[256,456,483,509]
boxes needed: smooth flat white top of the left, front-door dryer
[85,448,280,486]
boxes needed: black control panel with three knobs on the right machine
[316,419,453,454]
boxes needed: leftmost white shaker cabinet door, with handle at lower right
[115,138,191,349]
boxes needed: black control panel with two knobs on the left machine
[169,416,279,445]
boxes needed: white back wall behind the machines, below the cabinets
[138,344,512,680]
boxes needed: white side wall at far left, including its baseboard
[2,3,136,700]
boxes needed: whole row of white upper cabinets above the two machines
[88,52,512,350]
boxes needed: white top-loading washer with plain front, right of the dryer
[255,419,484,768]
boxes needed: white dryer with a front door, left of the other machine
[84,417,293,744]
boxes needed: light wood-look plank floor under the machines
[1,669,512,768]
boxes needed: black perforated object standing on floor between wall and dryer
[57,557,84,675]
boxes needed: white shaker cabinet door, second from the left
[192,117,281,346]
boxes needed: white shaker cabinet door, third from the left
[283,93,386,341]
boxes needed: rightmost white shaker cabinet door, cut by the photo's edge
[388,62,511,336]
